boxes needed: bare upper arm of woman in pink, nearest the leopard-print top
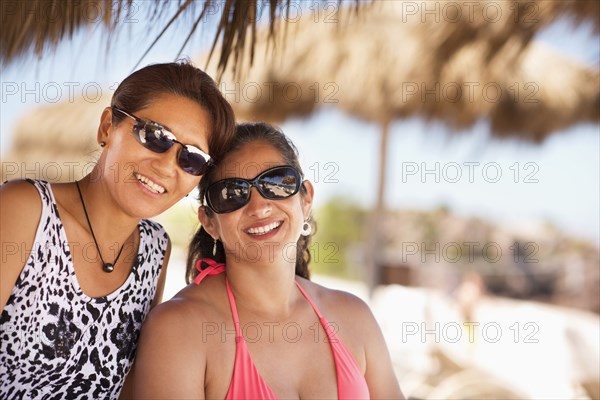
[133,299,206,399]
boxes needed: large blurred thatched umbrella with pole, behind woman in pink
[203,1,600,285]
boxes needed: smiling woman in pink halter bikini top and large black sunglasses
[135,123,403,399]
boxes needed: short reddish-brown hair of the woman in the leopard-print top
[110,60,235,160]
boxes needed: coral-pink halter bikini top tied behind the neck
[194,259,369,400]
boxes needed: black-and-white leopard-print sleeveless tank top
[0,180,168,399]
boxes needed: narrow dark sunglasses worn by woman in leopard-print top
[111,107,210,176]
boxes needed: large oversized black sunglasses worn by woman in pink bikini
[202,166,302,214]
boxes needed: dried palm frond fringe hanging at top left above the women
[0,0,358,76]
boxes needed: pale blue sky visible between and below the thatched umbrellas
[0,8,600,243]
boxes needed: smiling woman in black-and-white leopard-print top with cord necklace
[0,62,234,399]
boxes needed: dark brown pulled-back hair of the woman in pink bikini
[185,122,316,283]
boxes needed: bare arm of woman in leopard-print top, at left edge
[0,181,42,312]
